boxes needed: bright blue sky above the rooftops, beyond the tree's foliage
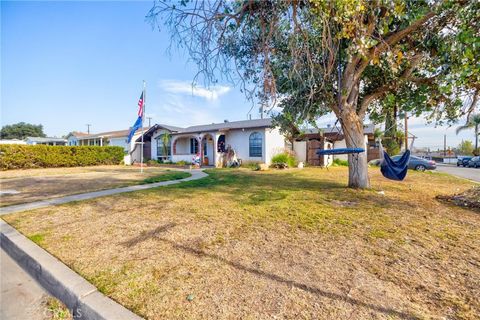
[1,1,473,148]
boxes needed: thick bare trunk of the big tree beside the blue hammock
[341,111,370,189]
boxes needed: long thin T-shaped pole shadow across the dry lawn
[120,223,419,319]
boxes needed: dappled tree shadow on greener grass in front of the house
[150,170,416,210]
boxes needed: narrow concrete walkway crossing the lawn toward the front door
[0,169,208,216]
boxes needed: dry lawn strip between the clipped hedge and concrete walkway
[0,166,181,206]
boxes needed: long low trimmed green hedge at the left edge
[0,144,124,170]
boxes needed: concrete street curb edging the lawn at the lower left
[0,220,143,320]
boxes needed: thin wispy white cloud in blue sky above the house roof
[159,80,231,101]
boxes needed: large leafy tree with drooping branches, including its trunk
[148,0,480,188]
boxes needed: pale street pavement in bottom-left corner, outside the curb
[0,249,50,320]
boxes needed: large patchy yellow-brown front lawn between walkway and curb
[3,168,480,319]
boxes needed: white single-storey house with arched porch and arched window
[139,119,285,166]
